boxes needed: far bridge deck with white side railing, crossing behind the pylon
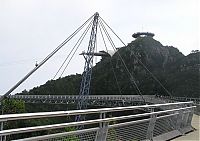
[9,95,165,107]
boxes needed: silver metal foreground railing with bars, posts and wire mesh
[0,102,195,141]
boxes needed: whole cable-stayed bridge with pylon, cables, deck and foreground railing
[0,13,199,141]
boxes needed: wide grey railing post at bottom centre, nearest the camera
[95,113,108,141]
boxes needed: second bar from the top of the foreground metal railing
[0,106,195,136]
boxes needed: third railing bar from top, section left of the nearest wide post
[13,127,99,141]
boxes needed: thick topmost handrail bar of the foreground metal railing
[0,101,193,122]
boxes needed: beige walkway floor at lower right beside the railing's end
[171,115,200,141]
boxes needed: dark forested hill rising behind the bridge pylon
[20,37,200,97]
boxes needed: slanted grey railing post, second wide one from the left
[146,107,157,141]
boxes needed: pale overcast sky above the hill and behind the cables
[0,0,200,95]
